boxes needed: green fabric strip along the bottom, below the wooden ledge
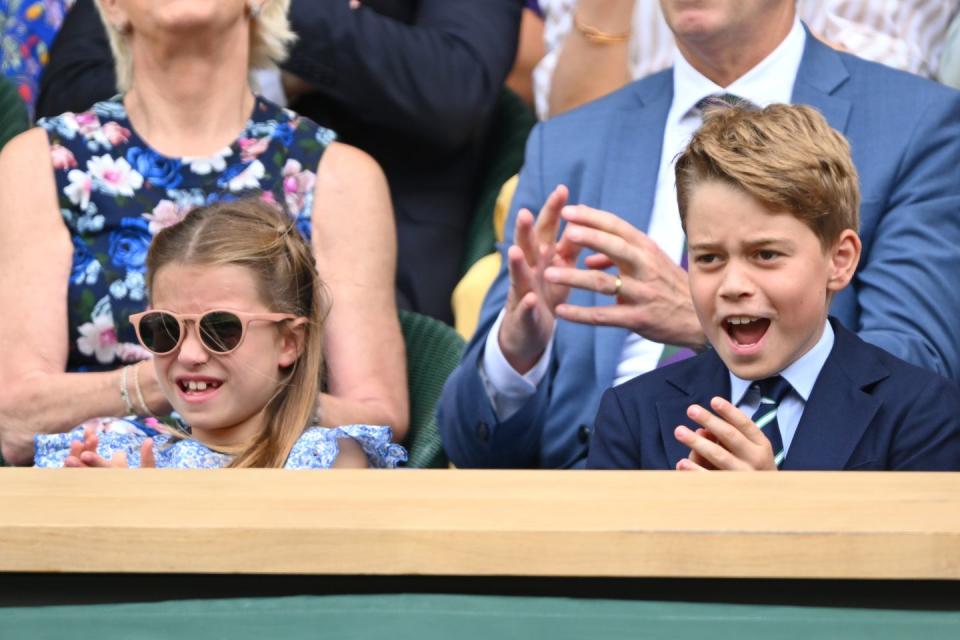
[0,594,960,640]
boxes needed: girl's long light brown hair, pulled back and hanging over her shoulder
[147,198,327,468]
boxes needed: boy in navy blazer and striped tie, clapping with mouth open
[587,105,960,471]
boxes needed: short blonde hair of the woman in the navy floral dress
[95,0,297,93]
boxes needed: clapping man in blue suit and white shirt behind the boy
[439,0,960,468]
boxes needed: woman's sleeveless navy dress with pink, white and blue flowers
[38,97,335,371]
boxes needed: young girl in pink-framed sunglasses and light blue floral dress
[35,200,406,469]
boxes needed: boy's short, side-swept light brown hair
[676,104,860,249]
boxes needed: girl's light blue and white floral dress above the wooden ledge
[34,418,407,469]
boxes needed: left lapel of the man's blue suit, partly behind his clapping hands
[585,75,673,383]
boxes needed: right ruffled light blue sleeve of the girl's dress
[284,424,407,469]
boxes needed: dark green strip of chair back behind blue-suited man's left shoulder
[463,89,537,273]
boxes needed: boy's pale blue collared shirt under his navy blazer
[730,322,834,455]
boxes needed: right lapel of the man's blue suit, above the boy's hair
[792,31,850,132]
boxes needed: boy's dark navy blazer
[587,320,960,471]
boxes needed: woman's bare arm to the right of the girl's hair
[313,143,409,441]
